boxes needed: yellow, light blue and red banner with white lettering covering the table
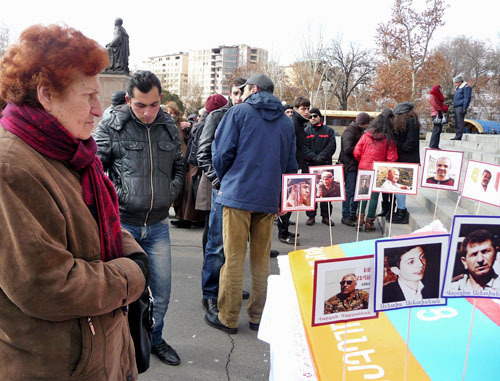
[289,240,500,381]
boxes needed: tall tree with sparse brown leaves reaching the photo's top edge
[375,0,447,100]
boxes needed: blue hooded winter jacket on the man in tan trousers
[212,91,297,213]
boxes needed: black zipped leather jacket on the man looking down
[93,105,184,226]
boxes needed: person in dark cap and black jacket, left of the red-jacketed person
[339,112,371,226]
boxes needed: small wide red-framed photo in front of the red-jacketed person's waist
[372,161,420,195]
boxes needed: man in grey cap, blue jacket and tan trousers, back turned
[205,74,297,334]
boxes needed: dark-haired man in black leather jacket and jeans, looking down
[94,70,184,365]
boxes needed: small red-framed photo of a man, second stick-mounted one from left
[309,164,345,202]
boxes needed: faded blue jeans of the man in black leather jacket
[122,218,172,346]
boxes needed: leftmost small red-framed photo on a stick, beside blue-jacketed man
[281,174,316,212]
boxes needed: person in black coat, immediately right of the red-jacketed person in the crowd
[386,102,420,224]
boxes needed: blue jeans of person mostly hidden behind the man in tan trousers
[201,189,224,299]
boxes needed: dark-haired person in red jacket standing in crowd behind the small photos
[353,110,398,231]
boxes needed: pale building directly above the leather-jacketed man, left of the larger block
[142,52,189,97]
